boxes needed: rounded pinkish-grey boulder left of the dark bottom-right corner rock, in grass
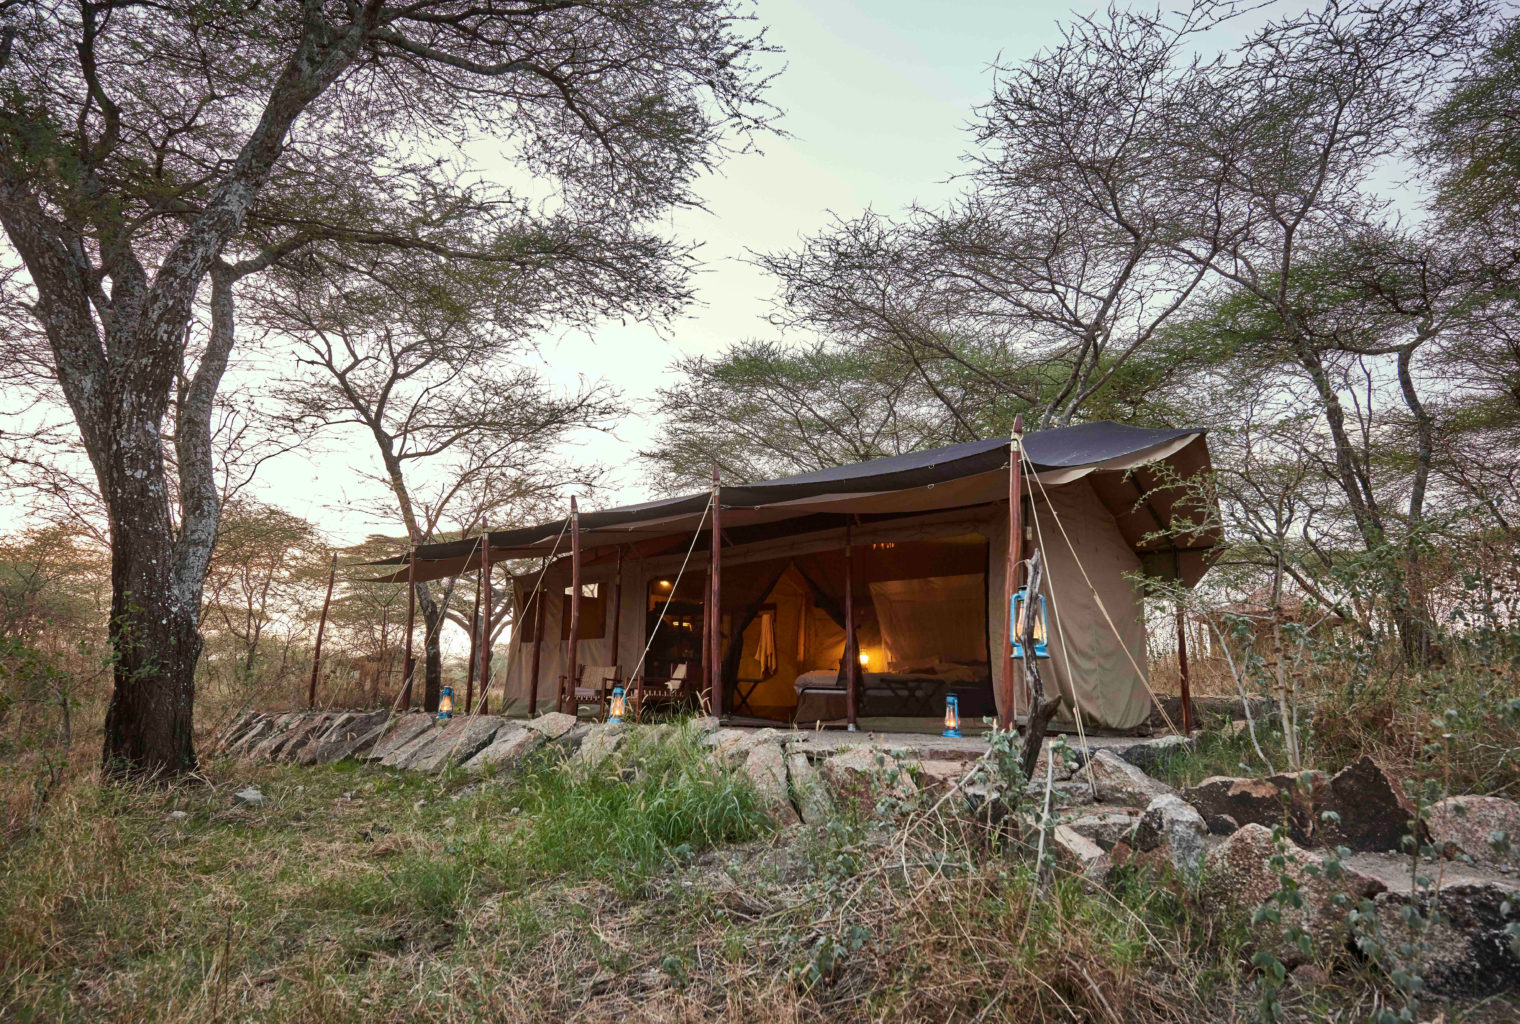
[1201,822,1385,968]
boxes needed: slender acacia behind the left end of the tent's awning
[270,250,626,710]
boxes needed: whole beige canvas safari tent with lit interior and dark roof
[380,422,1219,729]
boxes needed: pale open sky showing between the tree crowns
[246,0,1088,544]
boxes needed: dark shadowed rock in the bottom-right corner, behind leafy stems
[1374,880,1520,997]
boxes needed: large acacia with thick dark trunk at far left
[0,0,763,775]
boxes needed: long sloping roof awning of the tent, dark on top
[369,421,1219,583]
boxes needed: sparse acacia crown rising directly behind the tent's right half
[760,5,1221,441]
